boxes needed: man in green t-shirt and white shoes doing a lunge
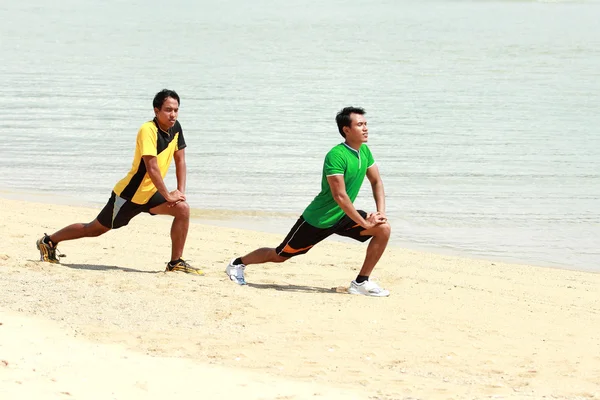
[225,107,391,297]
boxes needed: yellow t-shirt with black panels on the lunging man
[113,118,186,204]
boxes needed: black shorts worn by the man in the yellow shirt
[96,192,167,229]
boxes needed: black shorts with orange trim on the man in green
[275,210,371,257]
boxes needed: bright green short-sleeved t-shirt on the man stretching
[302,143,375,228]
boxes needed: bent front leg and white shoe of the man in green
[348,222,391,297]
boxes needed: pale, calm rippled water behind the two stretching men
[0,0,600,271]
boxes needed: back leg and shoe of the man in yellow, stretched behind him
[35,219,110,263]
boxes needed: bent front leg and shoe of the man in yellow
[150,201,204,275]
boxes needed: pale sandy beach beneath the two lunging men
[0,199,600,400]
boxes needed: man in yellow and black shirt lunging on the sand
[36,89,203,275]
